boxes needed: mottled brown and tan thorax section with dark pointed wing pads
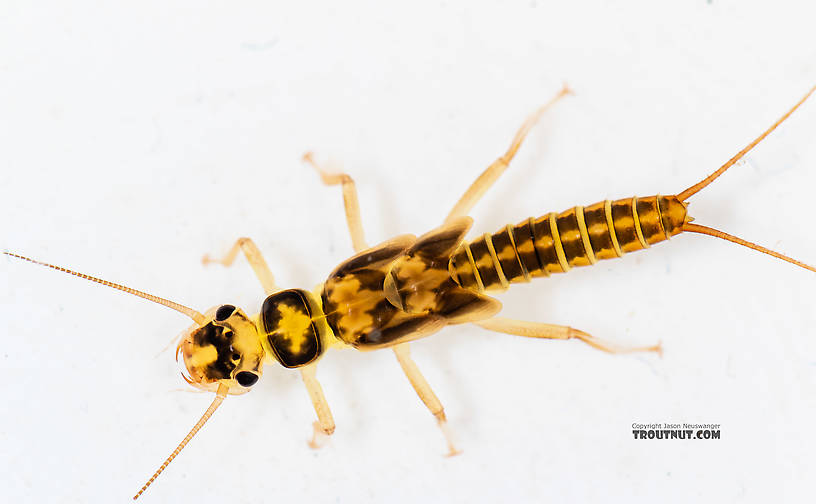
[322,218,501,350]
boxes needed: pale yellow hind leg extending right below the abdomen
[474,317,663,355]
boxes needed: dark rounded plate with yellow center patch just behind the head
[261,289,324,368]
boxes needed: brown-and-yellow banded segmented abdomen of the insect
[449,196,686,291]
